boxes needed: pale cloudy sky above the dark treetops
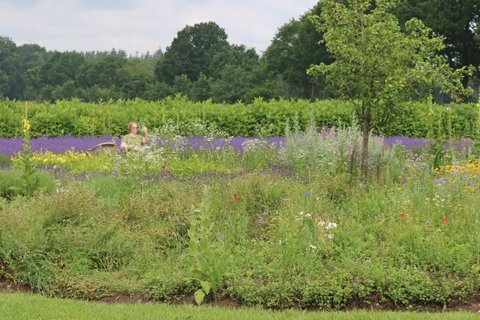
[0,0,317,55]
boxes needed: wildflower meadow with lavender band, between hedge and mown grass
[0,109,480,310]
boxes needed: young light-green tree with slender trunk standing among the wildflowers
[307,0,467,183]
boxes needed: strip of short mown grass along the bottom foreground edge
[0,293,478,320]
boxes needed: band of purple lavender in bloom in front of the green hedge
[0,136,473,156]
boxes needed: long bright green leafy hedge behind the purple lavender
[0,97,477,138]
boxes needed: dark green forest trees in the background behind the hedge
[0,0,480,103]
